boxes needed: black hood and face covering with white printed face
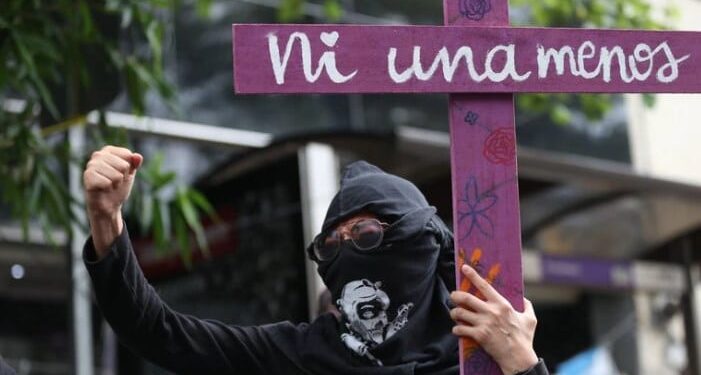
[308,162,457,367]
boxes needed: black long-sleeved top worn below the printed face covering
[83,228,547,375]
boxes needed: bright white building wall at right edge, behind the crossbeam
[627,0,701,185]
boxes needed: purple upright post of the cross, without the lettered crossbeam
[443,0,524,375]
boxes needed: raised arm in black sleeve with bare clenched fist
[83,146,271,374]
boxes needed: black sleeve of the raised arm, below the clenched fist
[83,226,284,374]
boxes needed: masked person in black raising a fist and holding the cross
[79,146,547,375]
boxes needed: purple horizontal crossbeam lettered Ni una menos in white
[233,25,701,93]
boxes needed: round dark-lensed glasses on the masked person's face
[313,219,389,262]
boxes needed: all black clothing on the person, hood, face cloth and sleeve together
[84,162,548,375]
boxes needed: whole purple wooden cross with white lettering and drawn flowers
[233,0,701,375]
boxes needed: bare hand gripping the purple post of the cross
[450,265,547,375]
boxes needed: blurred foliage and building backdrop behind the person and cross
[0,0,701,375]
